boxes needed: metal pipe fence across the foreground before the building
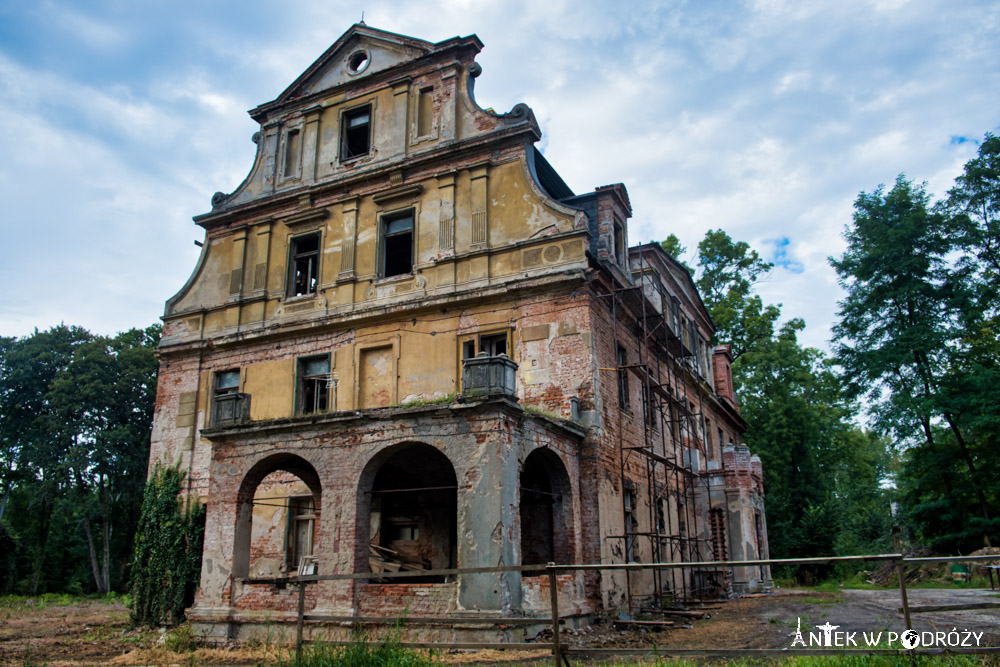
[236,554,1000,667]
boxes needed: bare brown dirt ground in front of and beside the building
[0,588,1000,667]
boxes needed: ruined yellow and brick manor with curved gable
[151,24,769,638]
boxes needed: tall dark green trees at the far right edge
[831,167,1000,552]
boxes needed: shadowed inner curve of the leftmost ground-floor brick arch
[232,452,323,577]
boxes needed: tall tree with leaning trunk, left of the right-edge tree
[830,176,996,542]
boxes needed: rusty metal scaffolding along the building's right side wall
[601,246,724,610]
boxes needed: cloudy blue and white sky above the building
[0,0,1000,347]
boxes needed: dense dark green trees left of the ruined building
[0,325,160,593]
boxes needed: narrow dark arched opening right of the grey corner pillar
[519,448,573,565]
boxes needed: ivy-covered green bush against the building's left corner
[129,465,205,625]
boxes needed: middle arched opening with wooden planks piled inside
[359,444,458,582]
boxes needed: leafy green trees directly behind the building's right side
[668,230,891,580]
